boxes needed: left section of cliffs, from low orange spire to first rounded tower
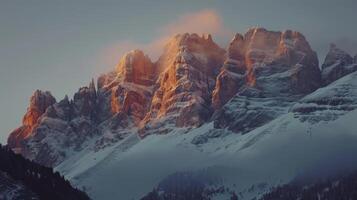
[8,50,157,166]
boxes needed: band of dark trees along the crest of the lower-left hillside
[0,144,90,200]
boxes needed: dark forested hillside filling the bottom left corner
[0,146,89,200]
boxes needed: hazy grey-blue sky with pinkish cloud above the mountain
[0,0,357,143]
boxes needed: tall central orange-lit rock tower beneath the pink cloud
[141,33,224,135]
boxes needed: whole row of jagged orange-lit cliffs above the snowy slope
[8,28,342,166]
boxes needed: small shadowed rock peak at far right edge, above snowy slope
[322,44,357,85]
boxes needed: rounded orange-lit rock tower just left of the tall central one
[98,50,158,124]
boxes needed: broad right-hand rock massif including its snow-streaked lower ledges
[212,28,321,133]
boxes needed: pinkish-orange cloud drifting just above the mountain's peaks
[101,10,233,66]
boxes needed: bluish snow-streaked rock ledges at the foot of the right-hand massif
[212,87,297,134]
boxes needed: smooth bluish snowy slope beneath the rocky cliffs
[57,73,357,200]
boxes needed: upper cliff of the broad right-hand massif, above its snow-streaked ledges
[212,28,321,109]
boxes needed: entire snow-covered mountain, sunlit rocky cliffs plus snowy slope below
[8,28,357,199]
